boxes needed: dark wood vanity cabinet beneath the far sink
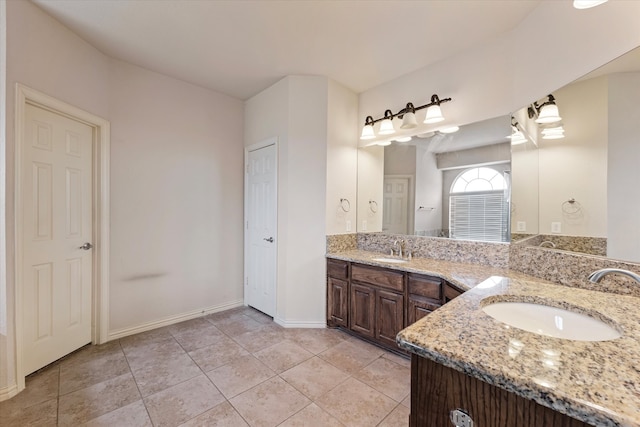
[327,259,461,354]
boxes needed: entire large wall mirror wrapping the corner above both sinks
[357,48,640,262]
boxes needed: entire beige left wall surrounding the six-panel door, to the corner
[0,1,243,394]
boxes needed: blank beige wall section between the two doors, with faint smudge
[109,60,243,334]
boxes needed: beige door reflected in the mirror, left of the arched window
[382,177,409,234]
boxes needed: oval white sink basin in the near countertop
[482,301,621,341]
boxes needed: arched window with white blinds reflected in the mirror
[449,167,509,242]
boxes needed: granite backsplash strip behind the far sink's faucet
[357,233,509,268]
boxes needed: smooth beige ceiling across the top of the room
[32,0,541,99]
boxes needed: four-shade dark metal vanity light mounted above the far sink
[360,94,451,140]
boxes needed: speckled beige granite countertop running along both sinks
[327,250,640,427]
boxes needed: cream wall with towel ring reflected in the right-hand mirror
[538,77,608,237]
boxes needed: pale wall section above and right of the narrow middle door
[245,76,342,327]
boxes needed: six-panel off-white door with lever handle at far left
[20,104,93,374]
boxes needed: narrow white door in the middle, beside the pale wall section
[245,145,277,317]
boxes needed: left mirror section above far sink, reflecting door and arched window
[358,116,511,242]
